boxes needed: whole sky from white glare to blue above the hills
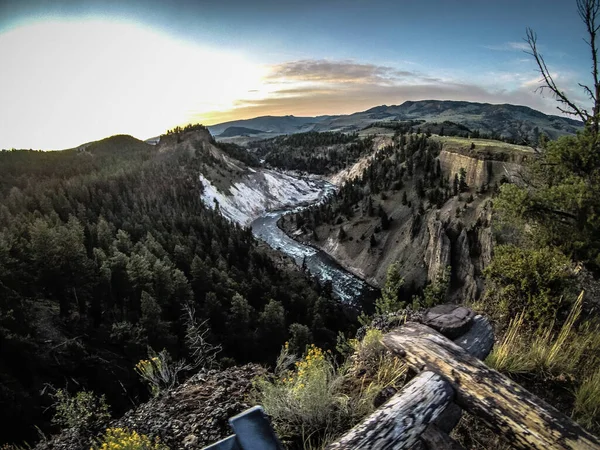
[0,0,591,150]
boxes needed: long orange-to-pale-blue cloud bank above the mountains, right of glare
[195,57,592,124]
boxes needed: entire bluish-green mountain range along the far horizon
[209,100,583,140]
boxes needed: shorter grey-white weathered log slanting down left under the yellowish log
[327,372,453,450]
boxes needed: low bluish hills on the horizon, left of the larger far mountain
[208,116,328,136]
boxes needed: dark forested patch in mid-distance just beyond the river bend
[251,131,373,175]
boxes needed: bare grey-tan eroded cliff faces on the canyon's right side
[287,146,506,302]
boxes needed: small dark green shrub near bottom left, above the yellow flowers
[52,389,110,429]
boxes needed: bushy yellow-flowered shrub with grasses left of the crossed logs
[256,336,406,448]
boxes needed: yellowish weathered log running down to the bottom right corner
[383,323,600,450]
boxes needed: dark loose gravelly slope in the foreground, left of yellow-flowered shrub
[35,364,265,450]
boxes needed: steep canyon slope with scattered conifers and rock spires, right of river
[283,133,490,298]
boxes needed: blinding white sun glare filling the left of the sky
[0,20,265,149]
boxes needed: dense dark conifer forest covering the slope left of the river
[0,136,354,442]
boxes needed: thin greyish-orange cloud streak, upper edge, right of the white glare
[267,59,436,84]
